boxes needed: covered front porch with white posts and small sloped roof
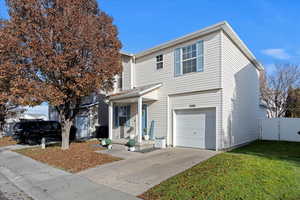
[109,84,162,145]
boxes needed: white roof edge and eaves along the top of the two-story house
[121,21,264,70]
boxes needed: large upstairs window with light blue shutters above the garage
[174,40,203,76]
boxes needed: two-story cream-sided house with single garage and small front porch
[108,22,263,150]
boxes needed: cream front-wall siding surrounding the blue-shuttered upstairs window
[134,31,221,146]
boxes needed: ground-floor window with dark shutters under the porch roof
[114,105,130,127]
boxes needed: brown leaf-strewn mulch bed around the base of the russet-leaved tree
[15,141,121,173]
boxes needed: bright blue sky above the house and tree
[0,0,300,114]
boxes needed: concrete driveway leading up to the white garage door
[79,145,218,196]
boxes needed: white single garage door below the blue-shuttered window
[175,109,216,149]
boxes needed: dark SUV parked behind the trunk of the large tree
[13,121,61,144]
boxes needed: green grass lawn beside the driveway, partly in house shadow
[141,141,300,200]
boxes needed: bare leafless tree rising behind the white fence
[260,64,300,118]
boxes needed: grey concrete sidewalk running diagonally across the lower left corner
[0,148,138,200]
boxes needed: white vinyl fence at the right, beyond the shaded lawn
[259,118,300,142]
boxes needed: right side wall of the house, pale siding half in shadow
[221,32,259,148]
